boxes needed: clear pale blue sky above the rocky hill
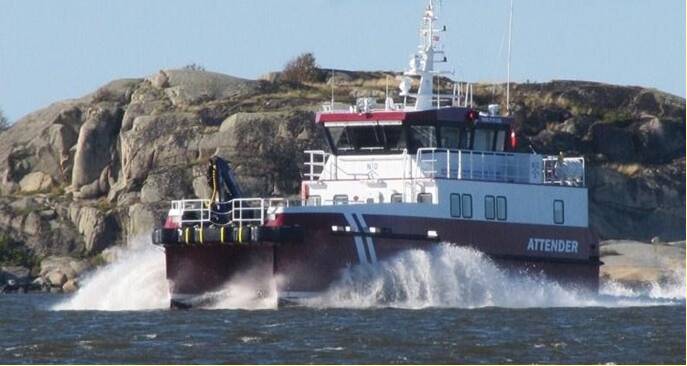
[0,0,685,120]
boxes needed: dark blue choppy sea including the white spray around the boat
[0,241,685,364]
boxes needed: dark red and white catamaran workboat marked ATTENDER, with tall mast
[152,1,601,308]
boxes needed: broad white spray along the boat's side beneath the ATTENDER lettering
[304,245,684,309]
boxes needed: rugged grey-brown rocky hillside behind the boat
[0,70,685,288]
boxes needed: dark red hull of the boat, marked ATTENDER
[166,213,600,306]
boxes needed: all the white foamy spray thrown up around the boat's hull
[53,237,685,311]
